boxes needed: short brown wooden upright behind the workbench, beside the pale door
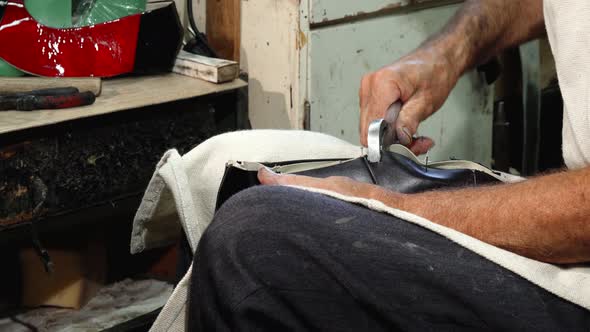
[207,0,242,62]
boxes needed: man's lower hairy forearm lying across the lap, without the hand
[398,168,590,263]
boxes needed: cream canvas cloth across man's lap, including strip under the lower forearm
[131,130,590,331]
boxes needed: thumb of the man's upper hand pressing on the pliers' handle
[395,98,427,146]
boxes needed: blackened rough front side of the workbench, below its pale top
[0,92,242,230]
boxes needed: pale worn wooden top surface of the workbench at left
[0,74,245,134]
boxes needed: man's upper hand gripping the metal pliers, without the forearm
[359,46,460,154]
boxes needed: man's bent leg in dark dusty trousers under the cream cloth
[191,187,590,330]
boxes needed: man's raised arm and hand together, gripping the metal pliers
[359,0,544,149]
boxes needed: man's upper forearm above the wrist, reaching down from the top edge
[424,0,545,76]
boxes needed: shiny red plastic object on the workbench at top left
[0,0,141,77]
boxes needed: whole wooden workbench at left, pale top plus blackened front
[0,74,245,232]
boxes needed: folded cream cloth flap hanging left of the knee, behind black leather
[131,130,363,253]
